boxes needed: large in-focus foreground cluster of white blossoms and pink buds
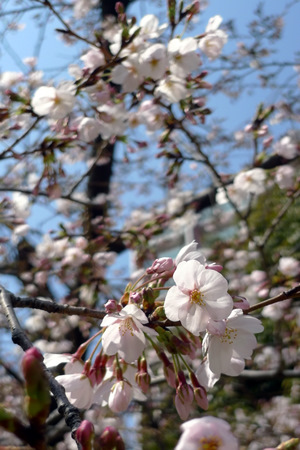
[46,241,263,420]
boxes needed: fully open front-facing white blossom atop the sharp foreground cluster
[164,260,233,335]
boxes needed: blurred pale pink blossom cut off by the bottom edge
[175,416,239,450]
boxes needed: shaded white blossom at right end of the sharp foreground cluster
[203,309,264,376]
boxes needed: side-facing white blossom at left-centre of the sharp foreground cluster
[101,304,157,363]
